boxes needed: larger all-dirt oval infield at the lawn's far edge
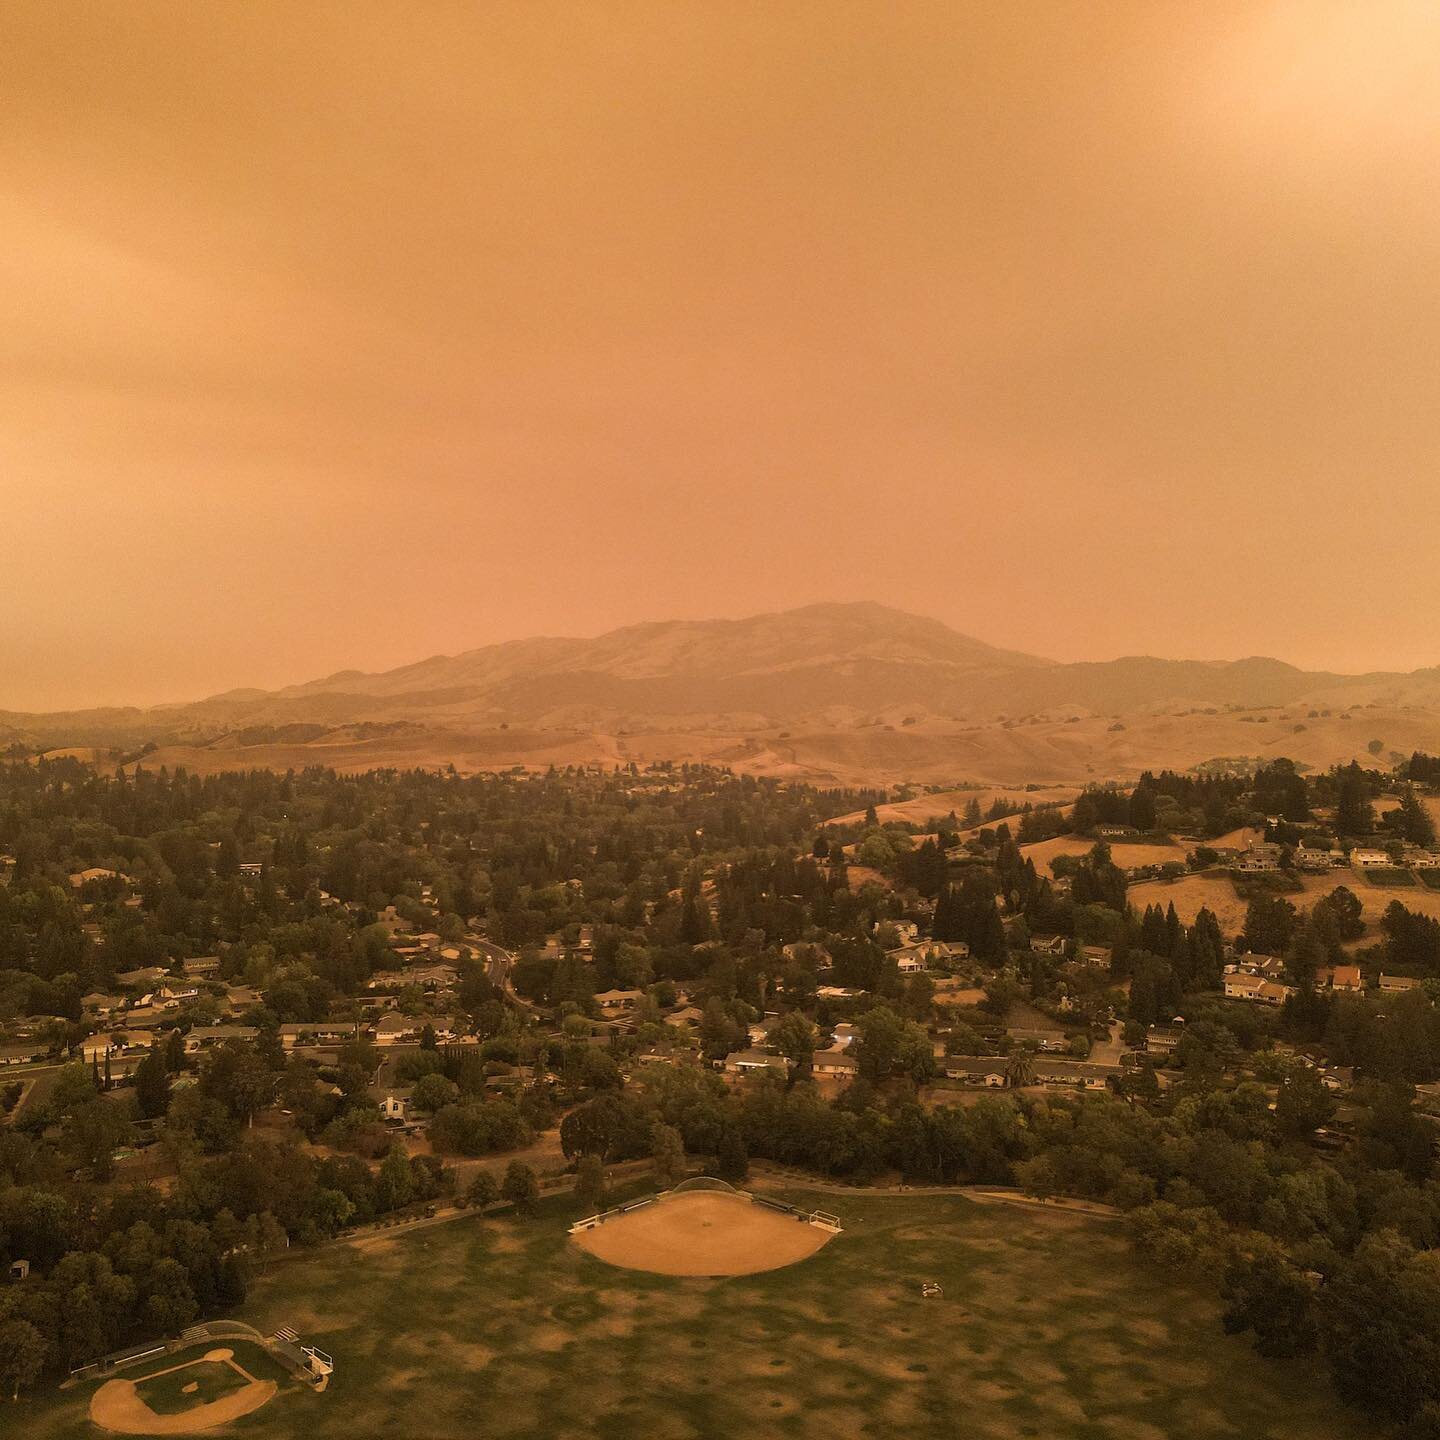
[573,1191,834,1274]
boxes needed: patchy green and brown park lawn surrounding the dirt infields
[28,1191,1367,1440]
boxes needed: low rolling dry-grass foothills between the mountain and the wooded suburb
[104,697,1440,789]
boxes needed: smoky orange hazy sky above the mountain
[0,0,1440,707]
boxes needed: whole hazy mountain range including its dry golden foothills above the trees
[0,603,1440,783]
